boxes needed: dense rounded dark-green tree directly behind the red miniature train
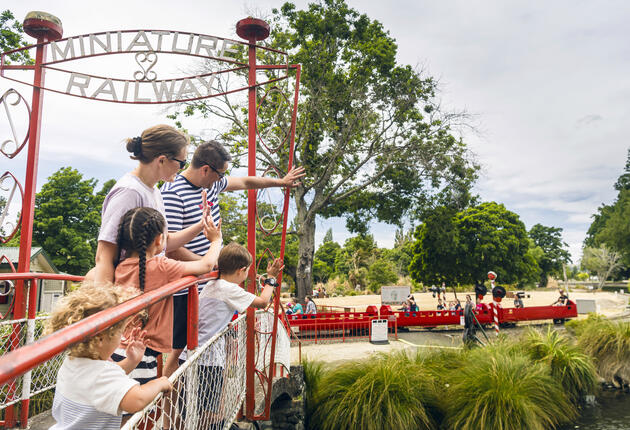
[409,202,538,284]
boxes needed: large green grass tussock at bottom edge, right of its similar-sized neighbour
[446,343,577,430]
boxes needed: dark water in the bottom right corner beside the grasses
[562,391,630,430]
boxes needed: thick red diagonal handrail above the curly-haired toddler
[0,276,206,384]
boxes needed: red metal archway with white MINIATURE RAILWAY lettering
[0,12,300,426]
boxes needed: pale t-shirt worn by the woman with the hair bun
[98,173,166,243]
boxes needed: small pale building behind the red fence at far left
[0,246,66,315]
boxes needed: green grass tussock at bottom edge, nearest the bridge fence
[311,355,437,430]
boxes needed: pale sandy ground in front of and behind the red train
[291,290,630,363]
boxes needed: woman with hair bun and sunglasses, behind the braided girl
[93,125,210,283]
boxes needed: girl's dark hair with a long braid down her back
[118,208,166,291]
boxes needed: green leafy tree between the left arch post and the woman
[33,167,115,275]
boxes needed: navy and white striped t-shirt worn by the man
[160,175,227,296]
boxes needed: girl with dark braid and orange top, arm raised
[112,207,222,402]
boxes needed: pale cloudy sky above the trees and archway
[0,0,630,260]
